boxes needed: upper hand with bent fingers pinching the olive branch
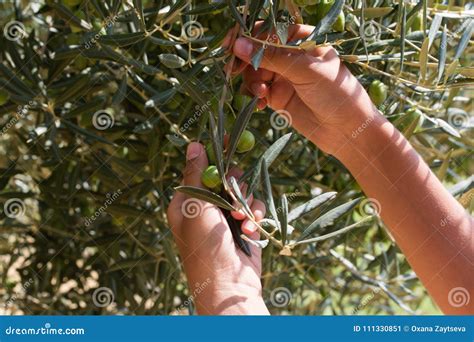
[223,25,378,154]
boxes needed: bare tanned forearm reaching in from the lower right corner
[336,113,474,314]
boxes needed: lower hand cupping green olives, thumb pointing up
[167,142,268,315]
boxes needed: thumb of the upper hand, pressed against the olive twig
[233,37,308,81]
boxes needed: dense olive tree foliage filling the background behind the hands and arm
[0,0,474,314]
